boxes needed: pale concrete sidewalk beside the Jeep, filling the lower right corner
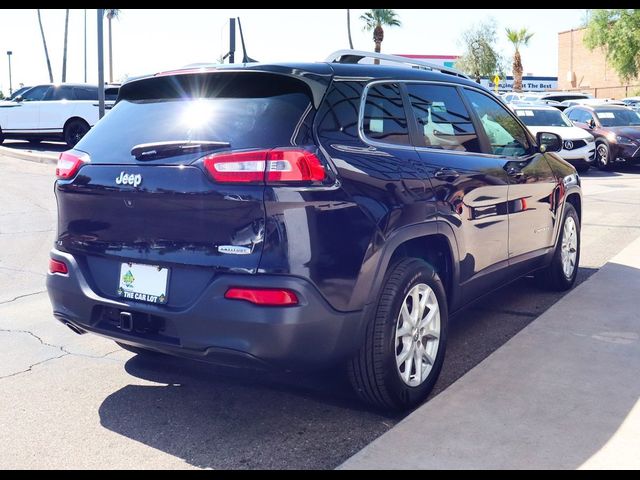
[339,239,640,469]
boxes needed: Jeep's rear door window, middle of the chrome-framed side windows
[407,84,480,152]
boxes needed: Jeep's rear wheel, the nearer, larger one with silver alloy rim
[348,258,448,410]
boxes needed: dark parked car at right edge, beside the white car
[565,104,640,170]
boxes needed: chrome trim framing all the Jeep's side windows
[358,79,538,158]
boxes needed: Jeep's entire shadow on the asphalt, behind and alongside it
[99,262,595,469]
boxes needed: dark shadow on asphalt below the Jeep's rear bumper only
[99,355,399,469]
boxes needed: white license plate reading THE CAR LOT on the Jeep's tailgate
[118,263,169,303]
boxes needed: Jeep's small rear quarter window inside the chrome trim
[363,83,410,145]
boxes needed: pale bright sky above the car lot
[0,9,585,94]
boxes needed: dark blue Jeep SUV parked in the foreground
[47,51,582,409]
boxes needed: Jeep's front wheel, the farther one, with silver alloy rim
[536,203,580,291]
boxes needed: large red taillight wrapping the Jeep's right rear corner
[203,148,325,184]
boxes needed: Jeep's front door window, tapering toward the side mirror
[465,89,531,157]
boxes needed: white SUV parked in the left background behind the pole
[0,83,118,147]
